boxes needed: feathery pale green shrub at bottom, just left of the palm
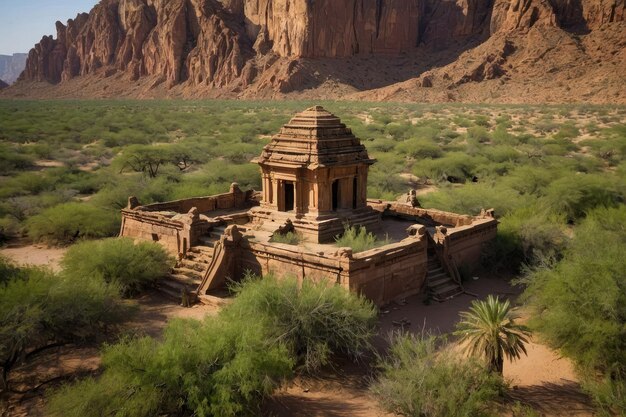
[371,334,504,417]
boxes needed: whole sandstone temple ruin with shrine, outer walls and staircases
[120,106,497,305]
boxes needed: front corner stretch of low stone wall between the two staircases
[236,232,428,305]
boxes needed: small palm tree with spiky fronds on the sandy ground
[454,295,530,374]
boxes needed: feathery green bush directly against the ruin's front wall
[224,276,376,372]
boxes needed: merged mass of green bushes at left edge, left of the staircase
[0,239,171,391]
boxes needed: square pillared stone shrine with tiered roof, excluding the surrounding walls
[252,106,380,242]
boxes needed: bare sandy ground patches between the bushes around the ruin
[0,246,593,417]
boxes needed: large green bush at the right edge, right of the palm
[525,206,626,413]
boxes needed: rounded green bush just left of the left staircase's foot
[61,238,173,296]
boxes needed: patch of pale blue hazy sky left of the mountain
[0,0,98,55]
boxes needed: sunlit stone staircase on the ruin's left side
[158,225,226,305]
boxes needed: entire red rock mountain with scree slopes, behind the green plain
[3,0,626,102]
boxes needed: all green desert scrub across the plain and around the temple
[0,101,626,415]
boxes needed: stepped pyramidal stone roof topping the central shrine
[255,106,375,170]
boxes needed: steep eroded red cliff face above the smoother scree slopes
[12,0,626,99]
